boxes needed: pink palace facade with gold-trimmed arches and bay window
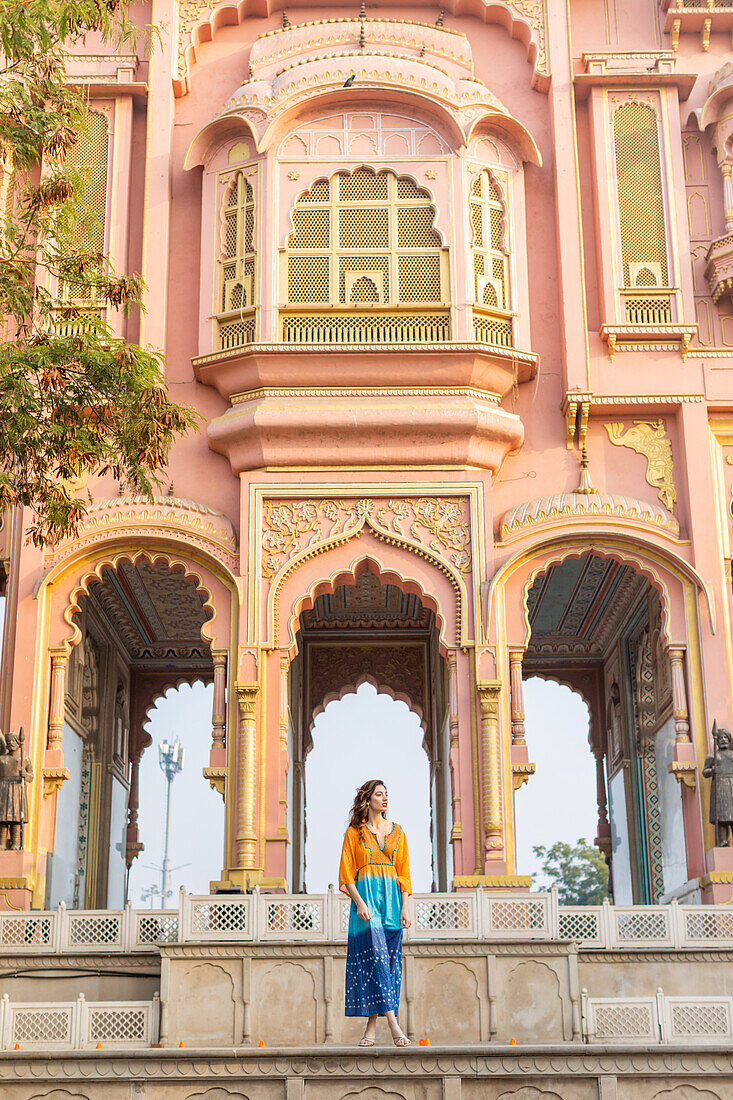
[0,0,733,908]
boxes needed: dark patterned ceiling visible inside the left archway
[89,560,209,662]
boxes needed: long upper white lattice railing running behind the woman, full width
[0,889,733,955]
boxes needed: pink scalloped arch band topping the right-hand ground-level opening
[486,525,715,647]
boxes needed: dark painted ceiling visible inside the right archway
[527,554,648,657]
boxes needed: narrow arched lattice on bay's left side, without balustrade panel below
[219,172,256,314]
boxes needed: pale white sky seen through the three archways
[129,679,598,908]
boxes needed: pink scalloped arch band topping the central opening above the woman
[274,543,466,656]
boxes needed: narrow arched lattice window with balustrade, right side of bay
[470,171,513,348]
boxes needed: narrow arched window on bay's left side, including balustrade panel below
[219,172,255,350]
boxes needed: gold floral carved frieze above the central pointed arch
[262,496,472,579]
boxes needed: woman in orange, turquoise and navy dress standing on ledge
[339,779,413,1046]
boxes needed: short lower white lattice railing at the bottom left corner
[0,993,160,1051]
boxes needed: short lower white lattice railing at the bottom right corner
[581,989,733,1043]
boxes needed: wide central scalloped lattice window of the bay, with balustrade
[281,168,449,343]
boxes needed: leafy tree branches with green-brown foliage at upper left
[0,0,196,545]
